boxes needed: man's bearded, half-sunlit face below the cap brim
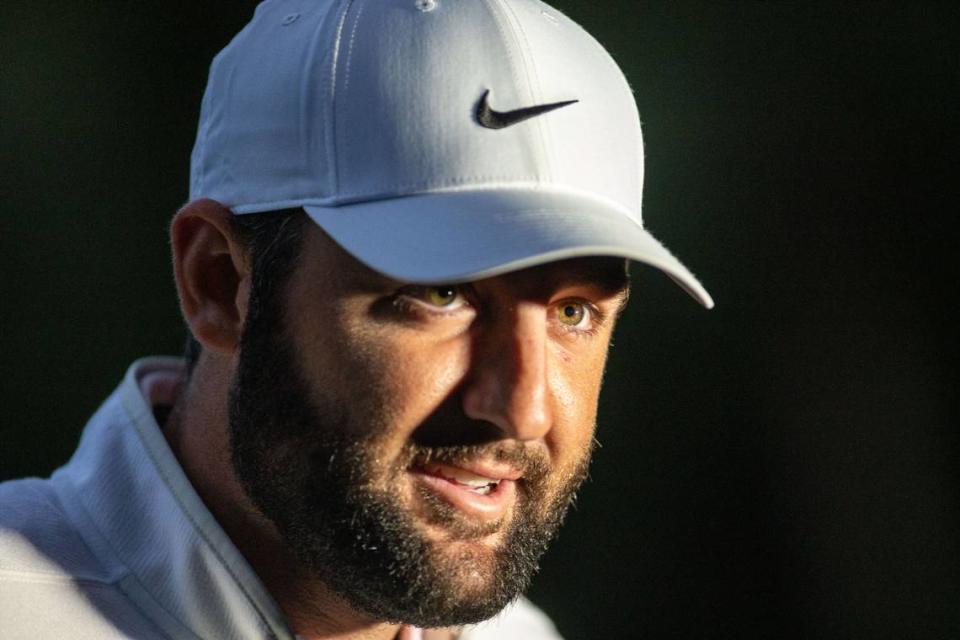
[230,224,626,627]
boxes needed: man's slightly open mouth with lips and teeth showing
[410,463,521,523]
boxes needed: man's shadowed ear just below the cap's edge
[170,199,250,354]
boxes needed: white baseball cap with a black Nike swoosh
[190,0,713,308]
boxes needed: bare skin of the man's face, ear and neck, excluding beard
[164,200,627,640]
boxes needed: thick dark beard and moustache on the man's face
[229,290,591,628]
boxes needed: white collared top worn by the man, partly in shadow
[0,358,559,640]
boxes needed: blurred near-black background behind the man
[0,0,960,638]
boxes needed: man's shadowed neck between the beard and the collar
[163,357,405,640]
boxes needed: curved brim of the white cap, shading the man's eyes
[303,189,713,309]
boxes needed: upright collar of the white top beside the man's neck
[53,358,293,640]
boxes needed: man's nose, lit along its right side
[462,304,554,440]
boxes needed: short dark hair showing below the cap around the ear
[184,208,307,380]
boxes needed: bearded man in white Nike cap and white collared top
[0,0,712,639]
